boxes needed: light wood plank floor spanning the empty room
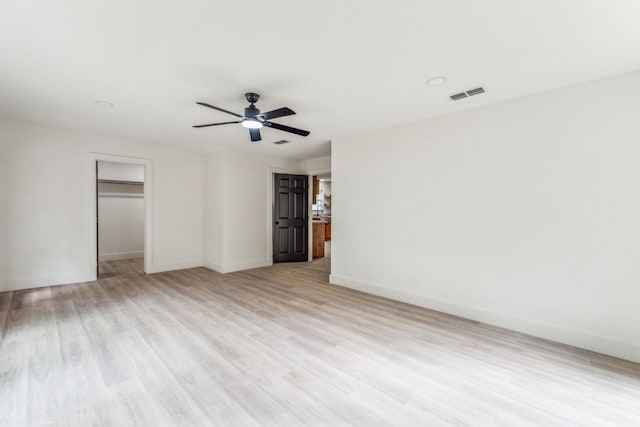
[0,259,640,426]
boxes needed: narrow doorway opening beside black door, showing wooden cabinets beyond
[311,172,332,259]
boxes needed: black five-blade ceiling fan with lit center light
[193,92,310,142]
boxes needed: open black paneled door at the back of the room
[273,173,309,263]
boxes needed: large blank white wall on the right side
[331,72,640,362]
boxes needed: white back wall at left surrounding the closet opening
[0,119,204,291]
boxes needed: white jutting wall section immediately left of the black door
[206,150,299,273]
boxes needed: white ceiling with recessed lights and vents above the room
[0,0,640,159]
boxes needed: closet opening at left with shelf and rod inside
[95,160,145,279]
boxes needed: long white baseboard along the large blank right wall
[329,274,640,363]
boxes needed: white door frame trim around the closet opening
[87,153,153,280]
